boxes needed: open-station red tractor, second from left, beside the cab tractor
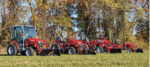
[51,27,96,55]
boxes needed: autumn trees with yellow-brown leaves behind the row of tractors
[0,0,149,47]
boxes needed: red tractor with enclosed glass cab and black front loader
[7,26,60,56]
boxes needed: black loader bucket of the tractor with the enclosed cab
[41,49,60,56]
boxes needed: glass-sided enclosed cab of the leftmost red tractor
[10,26,36,50]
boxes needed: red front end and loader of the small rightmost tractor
[123,42,143,53]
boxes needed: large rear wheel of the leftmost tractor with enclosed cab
[7,44,18,55]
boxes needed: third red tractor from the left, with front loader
[81,32,122,53]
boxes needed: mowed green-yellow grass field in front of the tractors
[0,50,149,67]
